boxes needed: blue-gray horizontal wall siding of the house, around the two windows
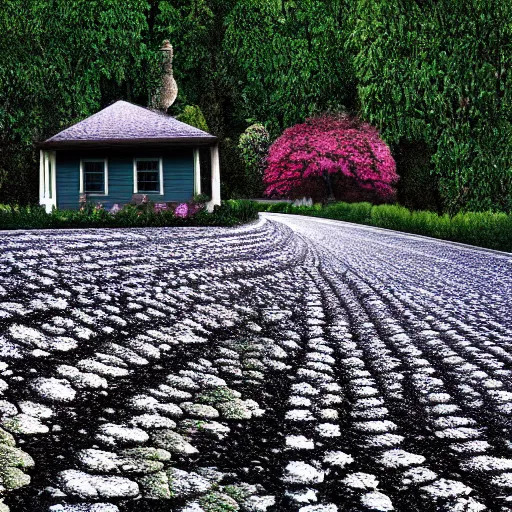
[56,149,194,209]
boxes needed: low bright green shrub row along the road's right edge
[258,203,512,252]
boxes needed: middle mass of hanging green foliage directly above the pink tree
[224,0,355,136]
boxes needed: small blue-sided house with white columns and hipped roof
[39,101,220,211]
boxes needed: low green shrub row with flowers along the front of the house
[0,199,258,230]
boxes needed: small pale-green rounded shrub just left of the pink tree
[238,123,270,197]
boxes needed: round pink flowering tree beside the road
[264,114,398,203]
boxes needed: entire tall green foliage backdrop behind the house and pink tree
[0,0,512,213]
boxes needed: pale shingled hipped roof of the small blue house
[40,101,217,149]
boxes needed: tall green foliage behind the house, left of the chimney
[0,0,157,203]
